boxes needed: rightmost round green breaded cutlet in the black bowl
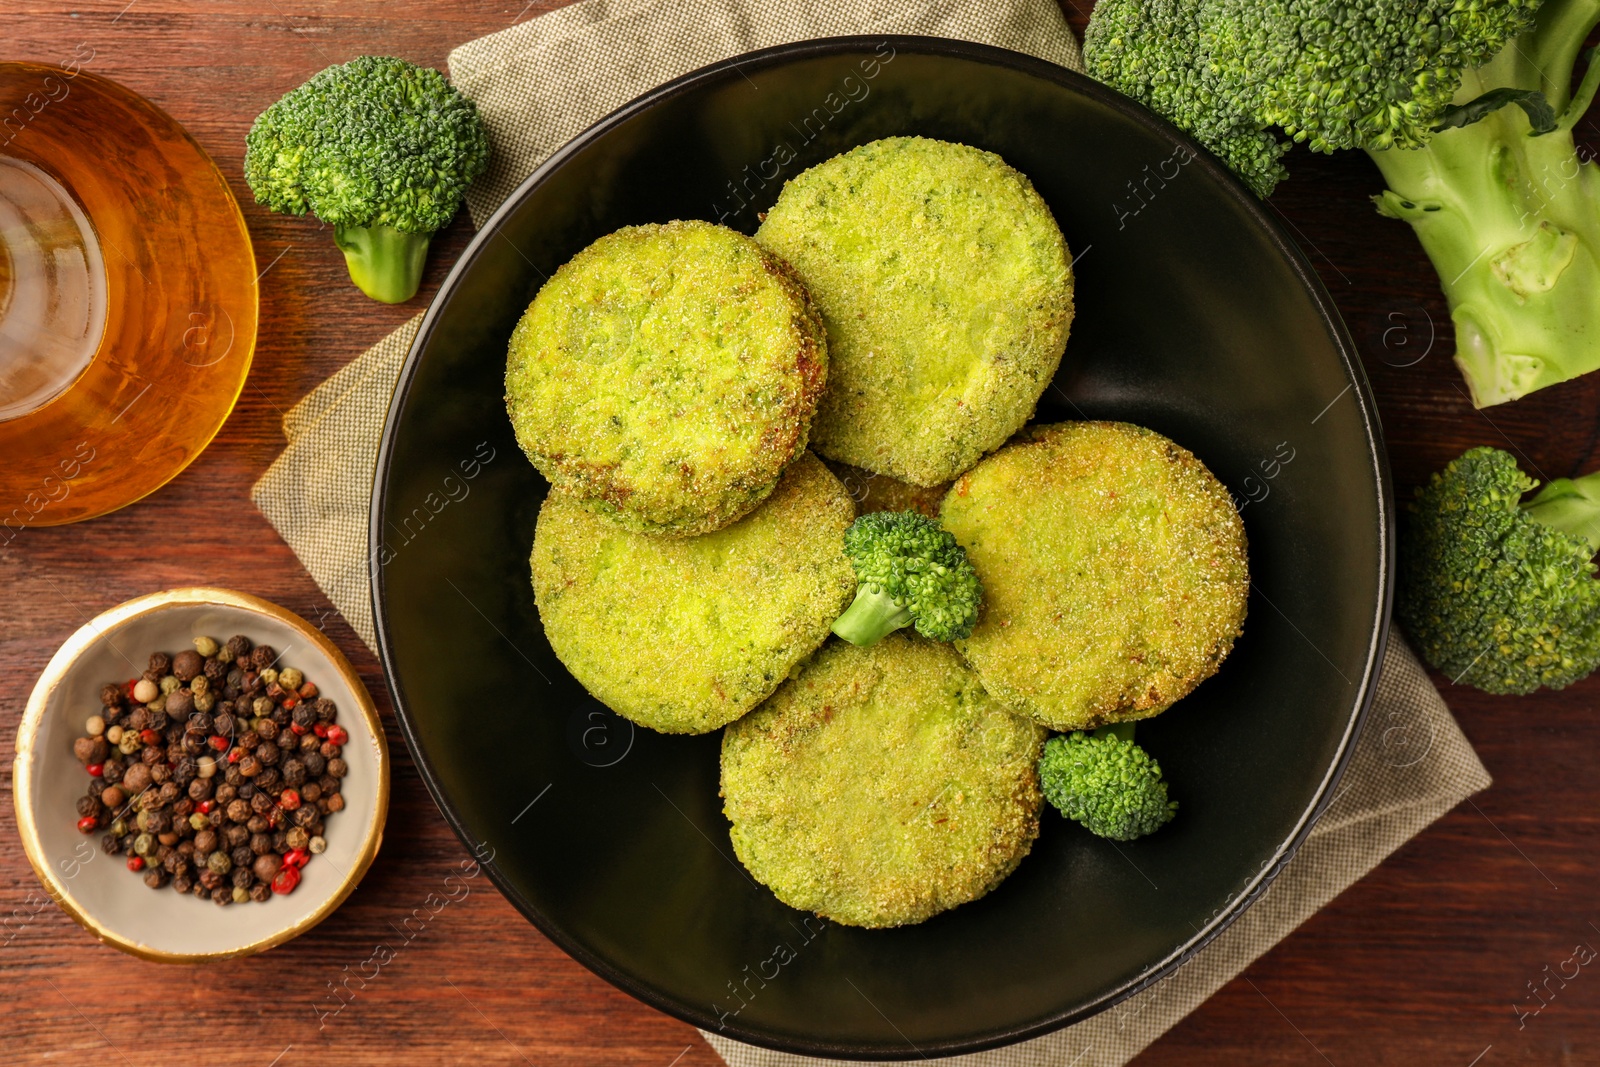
[941,422,1250,729]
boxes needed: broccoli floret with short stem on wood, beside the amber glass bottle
[245,56,490,304]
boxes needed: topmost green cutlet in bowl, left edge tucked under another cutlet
[755,138,1072,486]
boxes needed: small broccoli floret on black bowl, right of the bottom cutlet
[1038,723,1178,841]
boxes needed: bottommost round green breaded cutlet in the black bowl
[722,632,1045,926]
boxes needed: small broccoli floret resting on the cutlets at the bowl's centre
[834,512,984,646]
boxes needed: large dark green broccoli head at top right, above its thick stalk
[1083,0,1539,197]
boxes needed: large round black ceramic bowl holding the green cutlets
[371,37,1392,1057]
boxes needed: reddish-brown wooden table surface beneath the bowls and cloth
[0,0,1600,1067]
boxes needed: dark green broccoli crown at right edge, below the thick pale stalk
[1395,448,1600,693]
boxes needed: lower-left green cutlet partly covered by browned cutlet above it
[533,456,856,734]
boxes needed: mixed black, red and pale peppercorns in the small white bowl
[72,635,349,904]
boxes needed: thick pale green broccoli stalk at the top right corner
[1368,0,1600,408]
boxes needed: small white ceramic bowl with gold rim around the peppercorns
[11,589,389,963]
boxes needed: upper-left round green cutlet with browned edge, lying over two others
[506,222,827,536]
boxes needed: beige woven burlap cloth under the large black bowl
[253,0,1490,1067]
